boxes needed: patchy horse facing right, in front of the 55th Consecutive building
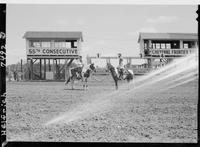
[65,63,96,89]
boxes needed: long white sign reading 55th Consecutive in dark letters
[27,48,79,56]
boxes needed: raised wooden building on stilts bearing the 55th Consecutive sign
[23,31,83,80]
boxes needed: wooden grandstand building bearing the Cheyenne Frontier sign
[138,33,198,67]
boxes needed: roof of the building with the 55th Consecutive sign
[23,31,83,41]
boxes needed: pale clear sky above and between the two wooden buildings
[6,4,198,65]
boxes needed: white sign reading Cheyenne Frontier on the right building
[149,48,196,55]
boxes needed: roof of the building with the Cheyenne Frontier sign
[138,33,198,42]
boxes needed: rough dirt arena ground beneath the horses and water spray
[6,76,198,143]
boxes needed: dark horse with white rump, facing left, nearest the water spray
[107,63,134,89]
